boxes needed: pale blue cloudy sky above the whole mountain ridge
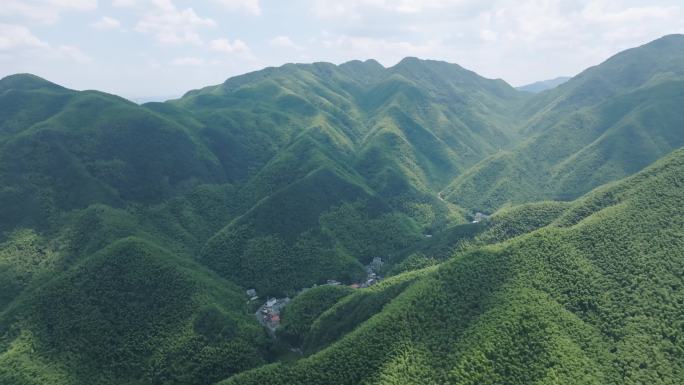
[0,0,684,100]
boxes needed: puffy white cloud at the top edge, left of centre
[135,0,216,44]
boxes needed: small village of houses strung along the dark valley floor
[247,257,383,338]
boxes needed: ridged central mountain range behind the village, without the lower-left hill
[0,58,524,294]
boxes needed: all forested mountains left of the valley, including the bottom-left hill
[0,54,524,385]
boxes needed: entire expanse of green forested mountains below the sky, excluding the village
[0,35,684,384]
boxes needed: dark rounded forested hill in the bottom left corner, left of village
[0,238,266,384]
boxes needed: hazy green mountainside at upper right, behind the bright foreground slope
[446,35,684,212]
